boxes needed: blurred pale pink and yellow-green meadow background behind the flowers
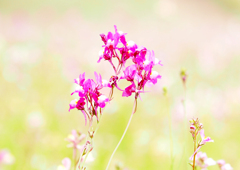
[0,0,240,170]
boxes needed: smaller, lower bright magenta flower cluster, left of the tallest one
[69,72,111,125]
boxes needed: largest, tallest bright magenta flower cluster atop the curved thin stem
[98,26,162,98]
